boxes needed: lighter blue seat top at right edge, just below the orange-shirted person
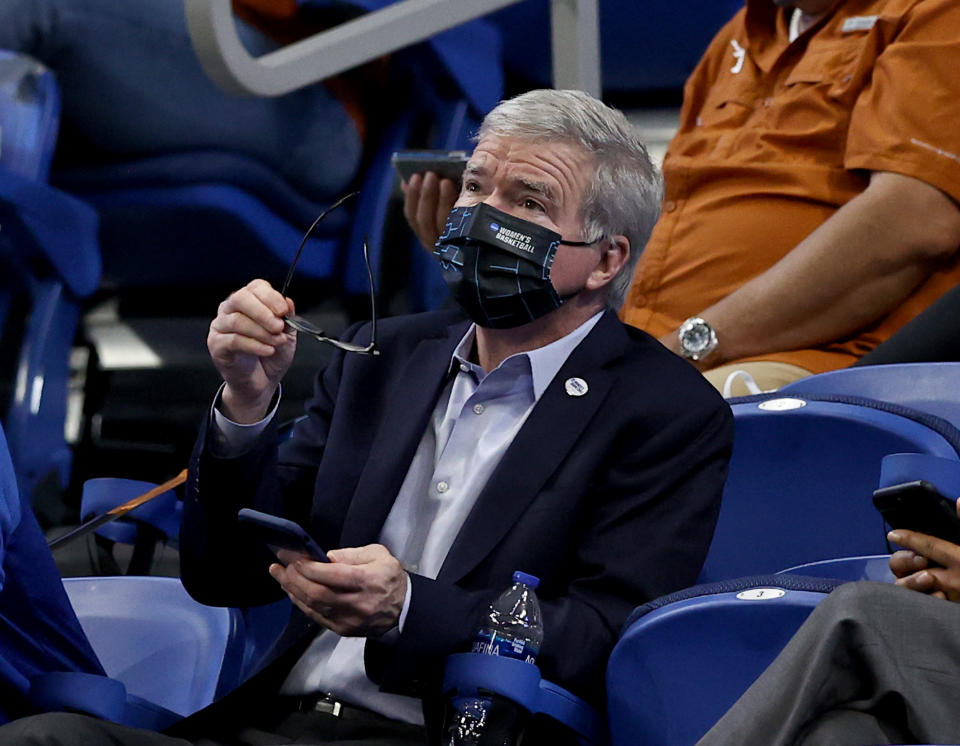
[779,363,960,426]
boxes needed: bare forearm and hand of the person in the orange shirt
[660,172,960,370]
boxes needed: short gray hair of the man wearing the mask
[477,89,663,309]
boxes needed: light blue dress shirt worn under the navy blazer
[214,313,602,723]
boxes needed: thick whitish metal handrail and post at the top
[186,0,600,96]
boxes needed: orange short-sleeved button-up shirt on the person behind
[623,0,960,372]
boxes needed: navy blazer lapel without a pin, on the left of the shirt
[342,323,468,546]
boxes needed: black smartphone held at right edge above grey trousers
[873,479,960,545]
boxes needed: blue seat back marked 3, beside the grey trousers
[607,575,840,746]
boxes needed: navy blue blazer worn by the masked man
[181,311,733,716]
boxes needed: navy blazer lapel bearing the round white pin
[439,311,627,582]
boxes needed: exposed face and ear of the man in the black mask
[457,134,601,296]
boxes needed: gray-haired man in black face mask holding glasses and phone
[0,91,731,744]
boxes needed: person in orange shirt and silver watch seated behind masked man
[405,0,960,393]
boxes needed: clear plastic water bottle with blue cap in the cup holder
[444,571,543,746]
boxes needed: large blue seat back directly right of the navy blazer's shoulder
[700,392,960,582]
